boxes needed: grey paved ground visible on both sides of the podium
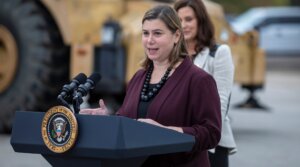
[0,56,300,167]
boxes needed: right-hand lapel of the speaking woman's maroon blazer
[147,57,193,120]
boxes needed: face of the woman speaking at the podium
[142,19,180,62]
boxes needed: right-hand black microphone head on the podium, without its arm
[73,73,101,100]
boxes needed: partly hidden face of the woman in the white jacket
[177,6,198,41]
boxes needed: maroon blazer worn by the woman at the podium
[117,58,221,167]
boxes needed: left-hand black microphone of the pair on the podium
[57,73,87,99]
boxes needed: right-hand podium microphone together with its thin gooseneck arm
[73,73,101,113]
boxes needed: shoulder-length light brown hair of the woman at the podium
[141,5,188,68]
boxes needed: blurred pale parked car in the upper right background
[231,7,300,56]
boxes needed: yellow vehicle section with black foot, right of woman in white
[203,0,267,109]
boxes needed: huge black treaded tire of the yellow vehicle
[0,0,69,132]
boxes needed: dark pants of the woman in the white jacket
[208,146,229,167]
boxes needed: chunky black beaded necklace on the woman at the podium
[141,64,172,102]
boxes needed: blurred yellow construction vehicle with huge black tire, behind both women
[0,0,264,130]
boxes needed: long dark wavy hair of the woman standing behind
[174,0,215,58]
